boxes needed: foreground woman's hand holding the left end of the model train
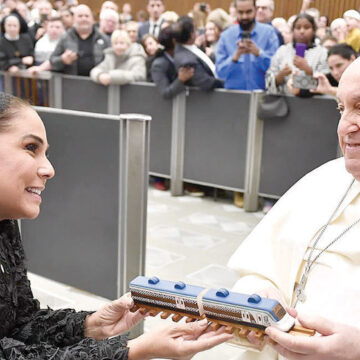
[84,293,145,340]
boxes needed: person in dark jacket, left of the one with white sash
[151,26,194,99]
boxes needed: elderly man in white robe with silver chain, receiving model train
[229,56,360,360]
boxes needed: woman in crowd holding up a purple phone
[266,13,329,96]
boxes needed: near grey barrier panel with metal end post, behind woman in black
[21,107,150,299]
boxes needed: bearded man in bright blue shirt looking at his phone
[216,0,279,91]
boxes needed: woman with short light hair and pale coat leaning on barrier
[90,30,146,86]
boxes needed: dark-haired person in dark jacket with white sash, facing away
[173,16,224,90]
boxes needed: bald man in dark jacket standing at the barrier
[50,5,110,76]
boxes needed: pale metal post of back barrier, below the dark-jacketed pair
[170,92,187,196]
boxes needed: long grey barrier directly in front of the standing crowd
[0,70,338,211]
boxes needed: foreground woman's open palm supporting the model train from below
[128,319,233,360]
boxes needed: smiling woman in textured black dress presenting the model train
[0,93,231,360]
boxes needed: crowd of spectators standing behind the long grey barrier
[0,0,360,205]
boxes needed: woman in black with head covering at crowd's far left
[0,15,34,72]
